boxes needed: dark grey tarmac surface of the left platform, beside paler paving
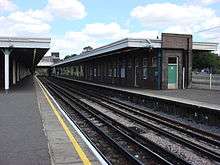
[0,78,51,165]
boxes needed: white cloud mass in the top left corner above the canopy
[0,0,86,36]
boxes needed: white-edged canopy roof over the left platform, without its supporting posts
[0,37,51,67]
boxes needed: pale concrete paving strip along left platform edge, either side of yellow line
[35,76,100,165]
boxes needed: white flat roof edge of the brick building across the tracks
[52,38,218,66]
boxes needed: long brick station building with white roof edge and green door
[52,33,218,89]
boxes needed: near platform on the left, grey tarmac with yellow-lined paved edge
[0,76,100,165]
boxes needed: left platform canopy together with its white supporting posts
[0,37,51,90]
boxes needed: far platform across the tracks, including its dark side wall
[52,76,220,125]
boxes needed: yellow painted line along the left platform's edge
[37,79,91,165]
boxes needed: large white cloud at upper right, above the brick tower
[131,3,220,28]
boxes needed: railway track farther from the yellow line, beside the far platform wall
[44,76,220,162]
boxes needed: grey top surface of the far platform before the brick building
[55,76,220,110]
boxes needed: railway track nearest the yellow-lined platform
[41,78,188,164]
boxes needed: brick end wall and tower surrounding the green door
[161,33,192,89]
